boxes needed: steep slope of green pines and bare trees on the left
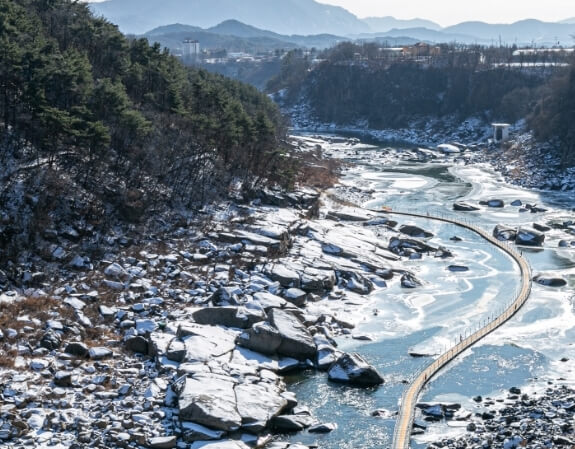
[0,0,290,258]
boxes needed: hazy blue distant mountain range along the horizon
[91,0,575,48]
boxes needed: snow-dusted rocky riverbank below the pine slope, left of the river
[0,136,448,449]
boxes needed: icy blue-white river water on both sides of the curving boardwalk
[289,135,575,449]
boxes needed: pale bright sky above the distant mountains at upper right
[318,0,575,26]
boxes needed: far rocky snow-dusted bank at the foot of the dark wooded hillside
[289,107,575,191]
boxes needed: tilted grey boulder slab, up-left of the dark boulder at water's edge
[269,309,317,360]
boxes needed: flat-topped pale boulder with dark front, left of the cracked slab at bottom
[178,374,242,431]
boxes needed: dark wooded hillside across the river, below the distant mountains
[267,43,575,165]
